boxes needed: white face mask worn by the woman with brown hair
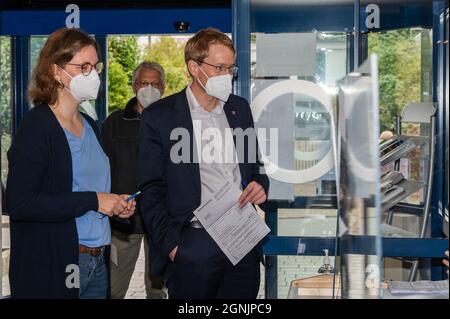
[60,67,100,101]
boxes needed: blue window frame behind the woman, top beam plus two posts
[0,7,232,132]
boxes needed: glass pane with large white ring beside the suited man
[251,0,353,298]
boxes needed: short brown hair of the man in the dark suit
[184,28,235,64]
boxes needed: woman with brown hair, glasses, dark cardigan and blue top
[6,29,135,298]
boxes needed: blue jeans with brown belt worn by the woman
[79,253,108,299]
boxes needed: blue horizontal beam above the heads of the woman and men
[0,7,231,36]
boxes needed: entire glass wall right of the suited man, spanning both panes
[250,0,442,298]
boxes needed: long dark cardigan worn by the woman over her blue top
[6,104,103,298]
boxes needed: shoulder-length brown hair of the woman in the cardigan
[28,28,98,104]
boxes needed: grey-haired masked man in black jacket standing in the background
[102,61,166,299]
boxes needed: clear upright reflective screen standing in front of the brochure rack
[338,56,381,299]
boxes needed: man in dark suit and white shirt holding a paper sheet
[138,29,269,299]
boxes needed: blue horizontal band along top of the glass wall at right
[251,1,432,33]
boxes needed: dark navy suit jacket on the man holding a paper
[138,90,269,275]
